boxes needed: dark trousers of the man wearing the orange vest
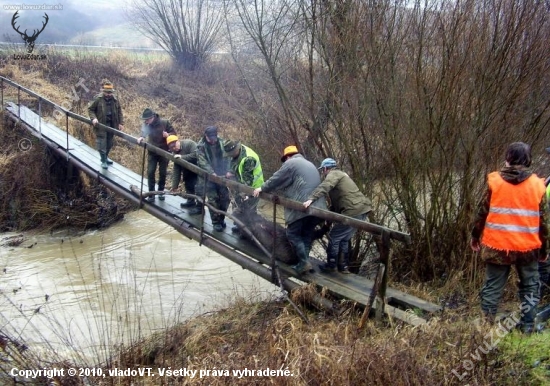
[480,261,540,326]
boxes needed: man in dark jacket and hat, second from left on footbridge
[138,108,176,202]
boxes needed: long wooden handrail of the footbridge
[0,76,410,243]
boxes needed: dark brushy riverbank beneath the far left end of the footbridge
[0,112,132,231]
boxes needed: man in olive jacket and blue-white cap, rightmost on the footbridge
[304,158,372,273]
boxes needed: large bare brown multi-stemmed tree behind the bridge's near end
[226,0,550,280]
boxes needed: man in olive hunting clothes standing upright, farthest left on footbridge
[88,79,124,169]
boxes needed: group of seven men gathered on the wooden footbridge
[88,79,372,275]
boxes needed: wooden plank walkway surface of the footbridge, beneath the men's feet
[6,103,441,325]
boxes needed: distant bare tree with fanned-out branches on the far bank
[129,0,223,70]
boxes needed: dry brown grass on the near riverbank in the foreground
[108,286,548,385]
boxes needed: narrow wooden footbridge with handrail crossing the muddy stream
[0,77,441,325]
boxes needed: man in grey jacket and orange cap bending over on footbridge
[254,146,327,275]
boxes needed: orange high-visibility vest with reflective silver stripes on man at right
[481,172,546,252]
